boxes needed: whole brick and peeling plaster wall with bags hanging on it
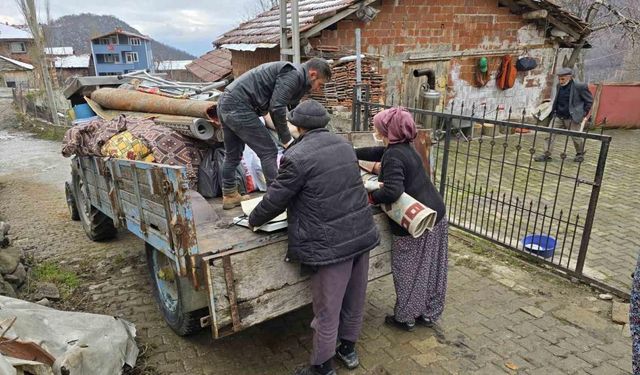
[310,0,555,117]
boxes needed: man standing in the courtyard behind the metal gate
[534,68,593,162]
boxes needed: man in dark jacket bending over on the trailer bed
[218,58,331,210]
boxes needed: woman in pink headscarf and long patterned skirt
[356,107,448,331]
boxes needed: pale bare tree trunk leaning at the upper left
[16,0,59,125]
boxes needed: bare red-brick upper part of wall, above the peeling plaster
[312,0,527,55]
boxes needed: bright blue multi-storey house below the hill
[91,29,154,76]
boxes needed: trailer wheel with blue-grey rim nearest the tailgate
[145,243,208,336]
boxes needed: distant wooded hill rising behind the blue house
[45,13,195,61]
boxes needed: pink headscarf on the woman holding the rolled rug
[373,107,418,144]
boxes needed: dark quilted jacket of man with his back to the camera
[249,128,380,266]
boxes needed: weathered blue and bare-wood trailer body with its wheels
[66,133,404,338]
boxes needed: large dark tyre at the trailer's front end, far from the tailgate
[73,175,118,241]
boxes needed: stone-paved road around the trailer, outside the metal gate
[0,107,631,375]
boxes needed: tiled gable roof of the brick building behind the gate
[214,0,588,46]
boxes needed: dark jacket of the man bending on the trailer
[225,61,311,143]
